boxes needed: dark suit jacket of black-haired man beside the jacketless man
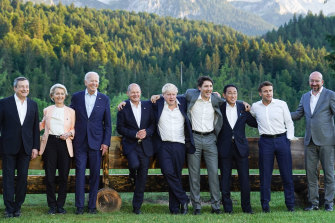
[217,102,257,158]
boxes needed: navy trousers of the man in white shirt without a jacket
[258,135,294,208]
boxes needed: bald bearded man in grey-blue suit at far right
[291,71,335,211]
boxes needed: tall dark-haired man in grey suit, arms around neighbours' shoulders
[184,76,223,215]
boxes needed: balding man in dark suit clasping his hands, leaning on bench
[117,84,155,214]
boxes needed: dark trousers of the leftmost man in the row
[2,143,31,213]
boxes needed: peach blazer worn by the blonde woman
[39,105,75,157]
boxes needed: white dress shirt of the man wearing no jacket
[250,99,294,139]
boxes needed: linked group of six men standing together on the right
[117,71,335,215]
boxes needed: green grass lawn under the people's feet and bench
[0,192,335,223]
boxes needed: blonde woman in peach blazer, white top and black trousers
[39,84,75,215]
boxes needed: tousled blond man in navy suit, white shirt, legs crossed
[153,83,195,214]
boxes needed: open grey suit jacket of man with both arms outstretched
[184,89,223,136]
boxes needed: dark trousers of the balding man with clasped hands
[127,145,150,209]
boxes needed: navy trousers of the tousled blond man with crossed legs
[159,142,189,213]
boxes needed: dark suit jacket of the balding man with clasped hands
[116,100,155,156]
